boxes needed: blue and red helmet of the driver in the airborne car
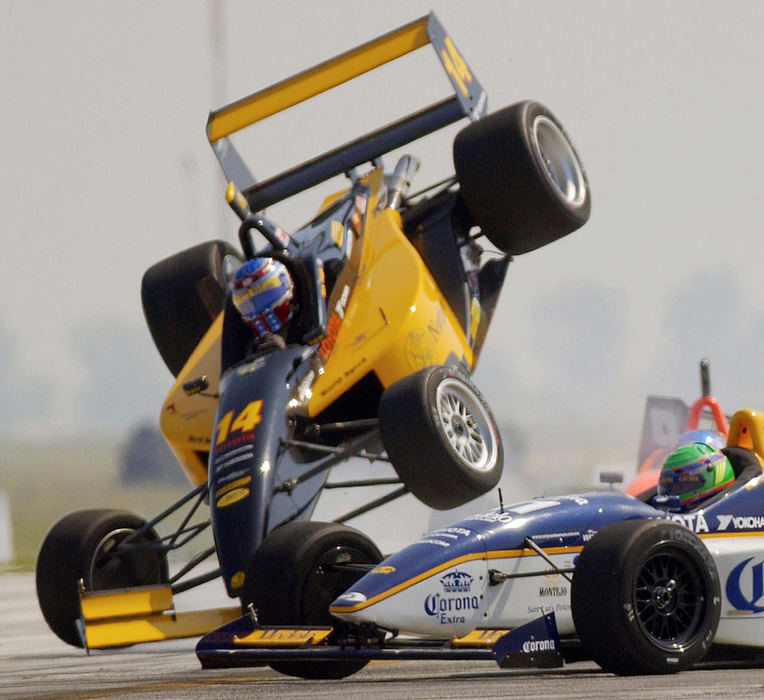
[231,258,294,338]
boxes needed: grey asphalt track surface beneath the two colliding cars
[0,573,764,700]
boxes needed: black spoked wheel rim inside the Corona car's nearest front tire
[634,550,706,651]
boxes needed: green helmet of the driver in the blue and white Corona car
[658,443,735,511]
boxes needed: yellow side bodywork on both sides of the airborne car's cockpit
[160,168,474,486]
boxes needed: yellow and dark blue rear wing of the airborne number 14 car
[207,13,487,211]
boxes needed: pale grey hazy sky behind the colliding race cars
[0,0,764,462]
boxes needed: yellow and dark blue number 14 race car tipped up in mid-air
[37,14,591,648]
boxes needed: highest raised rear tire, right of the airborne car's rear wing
[453,100,591,255]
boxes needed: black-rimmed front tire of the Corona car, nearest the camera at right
[571,520,721,675]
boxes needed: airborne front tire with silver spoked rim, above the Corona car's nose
[379,365,504,510]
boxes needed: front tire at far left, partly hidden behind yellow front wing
[35,509,168,647]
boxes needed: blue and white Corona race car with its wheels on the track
[197,410,764,677]
